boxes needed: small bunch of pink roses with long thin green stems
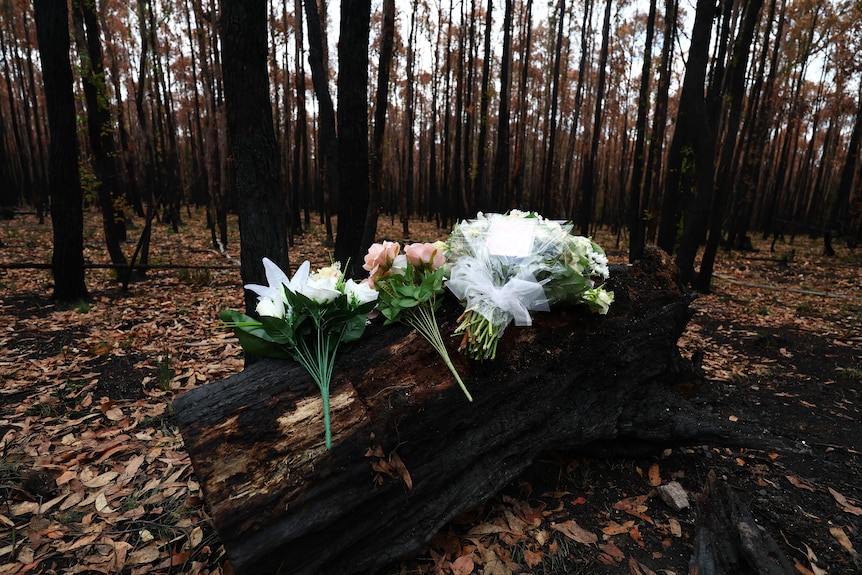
[363,242,473,401]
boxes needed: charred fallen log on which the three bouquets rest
[174,249,768,574]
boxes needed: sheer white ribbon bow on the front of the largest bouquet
[446,257,550,332]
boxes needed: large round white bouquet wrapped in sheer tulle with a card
[446,210,614,360]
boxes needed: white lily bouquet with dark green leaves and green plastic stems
[219,258,378,449]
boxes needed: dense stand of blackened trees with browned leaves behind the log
[0,0,862,301]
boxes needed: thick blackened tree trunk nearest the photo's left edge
[33,0,88,302]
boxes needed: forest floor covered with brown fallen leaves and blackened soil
[0,208,862,575]
